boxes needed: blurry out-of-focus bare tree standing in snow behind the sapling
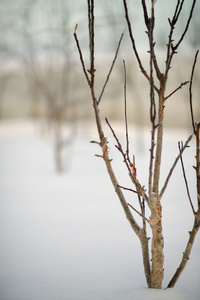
[22,1,75,172]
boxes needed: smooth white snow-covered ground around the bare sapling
[0,121,200,300]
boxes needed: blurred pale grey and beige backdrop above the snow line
[0,0,200,128]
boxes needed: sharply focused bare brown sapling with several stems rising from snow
[74,0,200,289]
